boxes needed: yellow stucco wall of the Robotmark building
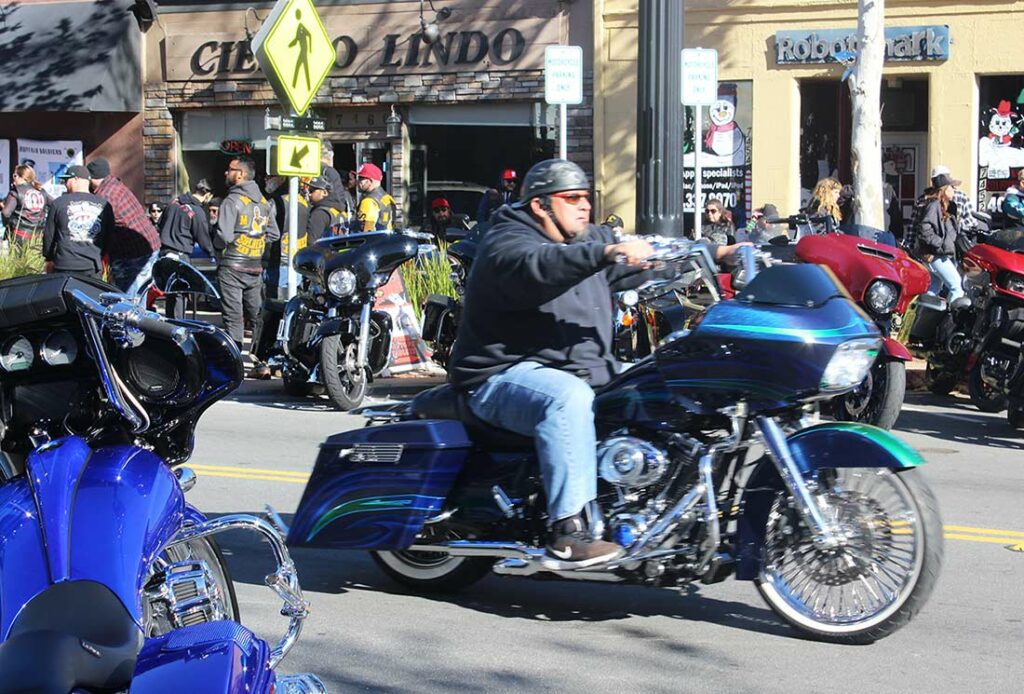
[594,0,1024,220]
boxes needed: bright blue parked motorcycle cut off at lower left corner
[0,260,325,694]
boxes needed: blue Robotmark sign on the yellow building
[775,26,949,66]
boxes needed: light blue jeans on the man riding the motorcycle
[469,361,597,522]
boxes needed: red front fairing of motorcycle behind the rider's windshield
[797,233,932,313]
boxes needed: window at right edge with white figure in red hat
[978,75,1024,212]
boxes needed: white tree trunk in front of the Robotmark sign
[850,0,886,229]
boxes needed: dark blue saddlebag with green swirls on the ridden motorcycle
[288,420,471,550]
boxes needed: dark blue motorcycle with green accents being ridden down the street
[289,243,943,644]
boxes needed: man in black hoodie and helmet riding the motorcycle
[452,160,745,569]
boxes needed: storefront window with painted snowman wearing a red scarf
[683,80,757,233]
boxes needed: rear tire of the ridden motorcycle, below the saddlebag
[370,551,495,593]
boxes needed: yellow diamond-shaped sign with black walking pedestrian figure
[252,0,337,116]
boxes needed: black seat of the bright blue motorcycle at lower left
[0,580,142,694]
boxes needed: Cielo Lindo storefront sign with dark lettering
[165,15,559,81]
